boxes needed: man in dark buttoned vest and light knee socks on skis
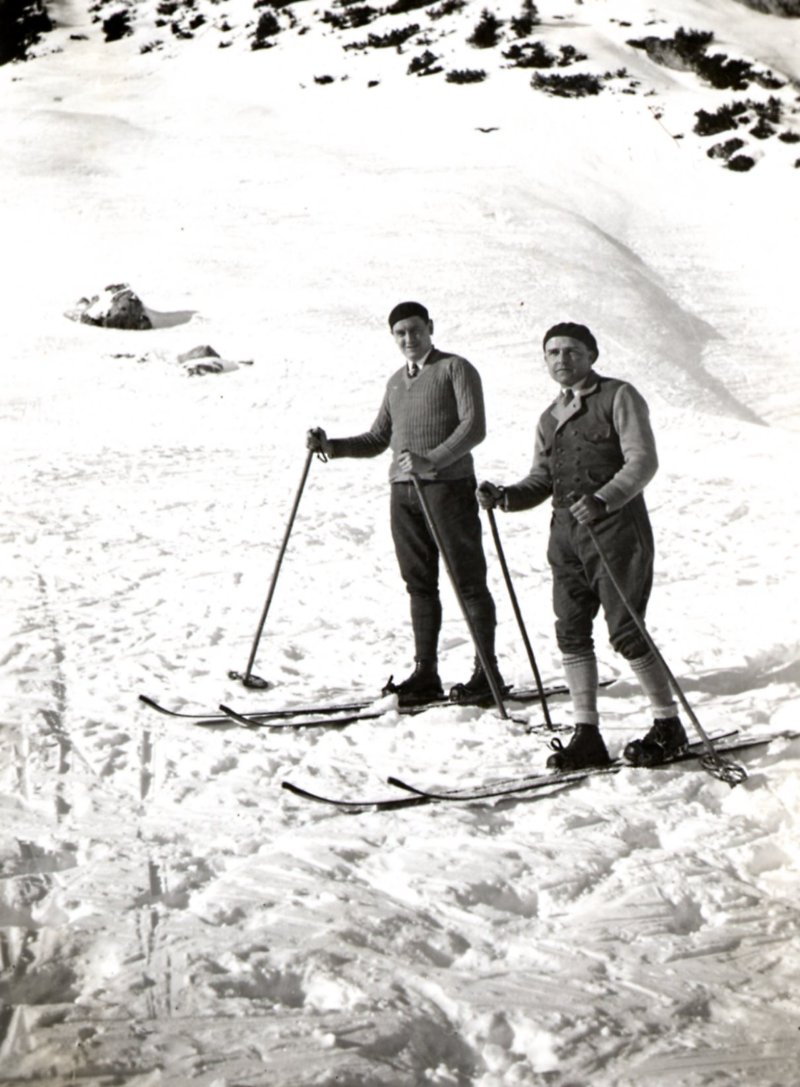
[478,322,687,770]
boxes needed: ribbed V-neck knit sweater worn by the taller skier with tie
[330,348,486,483]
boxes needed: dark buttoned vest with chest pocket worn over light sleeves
[541,377,625,507]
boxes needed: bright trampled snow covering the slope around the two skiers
[0,0,800,1087]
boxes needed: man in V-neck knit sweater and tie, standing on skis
[307,302,502,704]
